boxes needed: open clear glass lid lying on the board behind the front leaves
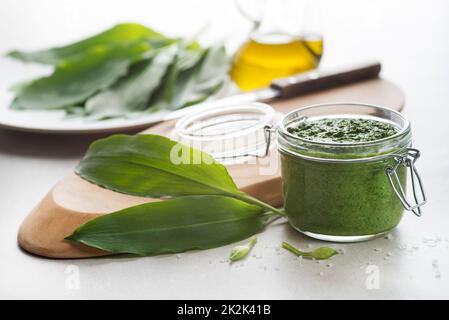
[172,102,281,164]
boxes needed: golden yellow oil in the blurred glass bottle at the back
[231,35,323,91]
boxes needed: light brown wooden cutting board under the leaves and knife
[18,79,404,258]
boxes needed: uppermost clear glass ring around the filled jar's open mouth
[277,102,411,147]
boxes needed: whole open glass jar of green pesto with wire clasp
[277,103,426,242]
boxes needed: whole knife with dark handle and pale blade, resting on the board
[164,61,381,121]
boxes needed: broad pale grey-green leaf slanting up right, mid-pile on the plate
[86,45,177,119]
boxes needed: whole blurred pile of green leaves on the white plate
[8,23,229,119]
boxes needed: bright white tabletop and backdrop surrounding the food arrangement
[0,0,449,299]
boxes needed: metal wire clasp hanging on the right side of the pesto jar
[385,148,427,217]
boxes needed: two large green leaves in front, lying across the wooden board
[66,135,336,261]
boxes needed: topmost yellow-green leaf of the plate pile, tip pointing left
[8,23,168,65]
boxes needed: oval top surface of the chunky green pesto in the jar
[287,118,397,143]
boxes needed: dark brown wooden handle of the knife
[271,62,381,98]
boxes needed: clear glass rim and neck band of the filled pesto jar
[276,102,411,163]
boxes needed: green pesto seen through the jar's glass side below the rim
[281,119,406,236]
